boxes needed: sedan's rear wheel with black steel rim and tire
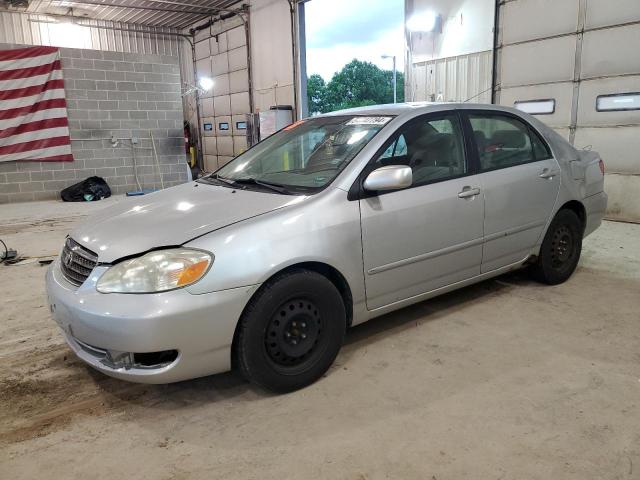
[531,209,584,285]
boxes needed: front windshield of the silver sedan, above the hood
[211,115,391,193]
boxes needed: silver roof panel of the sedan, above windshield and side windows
[320,102,523,117]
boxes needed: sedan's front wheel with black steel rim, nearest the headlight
[235,269,346,393]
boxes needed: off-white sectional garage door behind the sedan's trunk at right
[496,0,640,222]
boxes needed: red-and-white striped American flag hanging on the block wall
[0,47,73,162]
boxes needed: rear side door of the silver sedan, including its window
[467,111,560,273]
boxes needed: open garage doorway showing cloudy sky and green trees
[299,0,405,116]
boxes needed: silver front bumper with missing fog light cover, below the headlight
[46,260,258,383]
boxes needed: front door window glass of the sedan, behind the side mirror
[374,115,467,186]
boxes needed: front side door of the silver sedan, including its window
[359,112,484,310]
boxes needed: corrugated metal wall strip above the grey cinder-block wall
[0,12,184,56]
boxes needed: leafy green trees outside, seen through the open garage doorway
[307,59,404,114]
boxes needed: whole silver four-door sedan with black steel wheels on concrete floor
[46,104,607,392]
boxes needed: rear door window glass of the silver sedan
[469,114,550,171]
